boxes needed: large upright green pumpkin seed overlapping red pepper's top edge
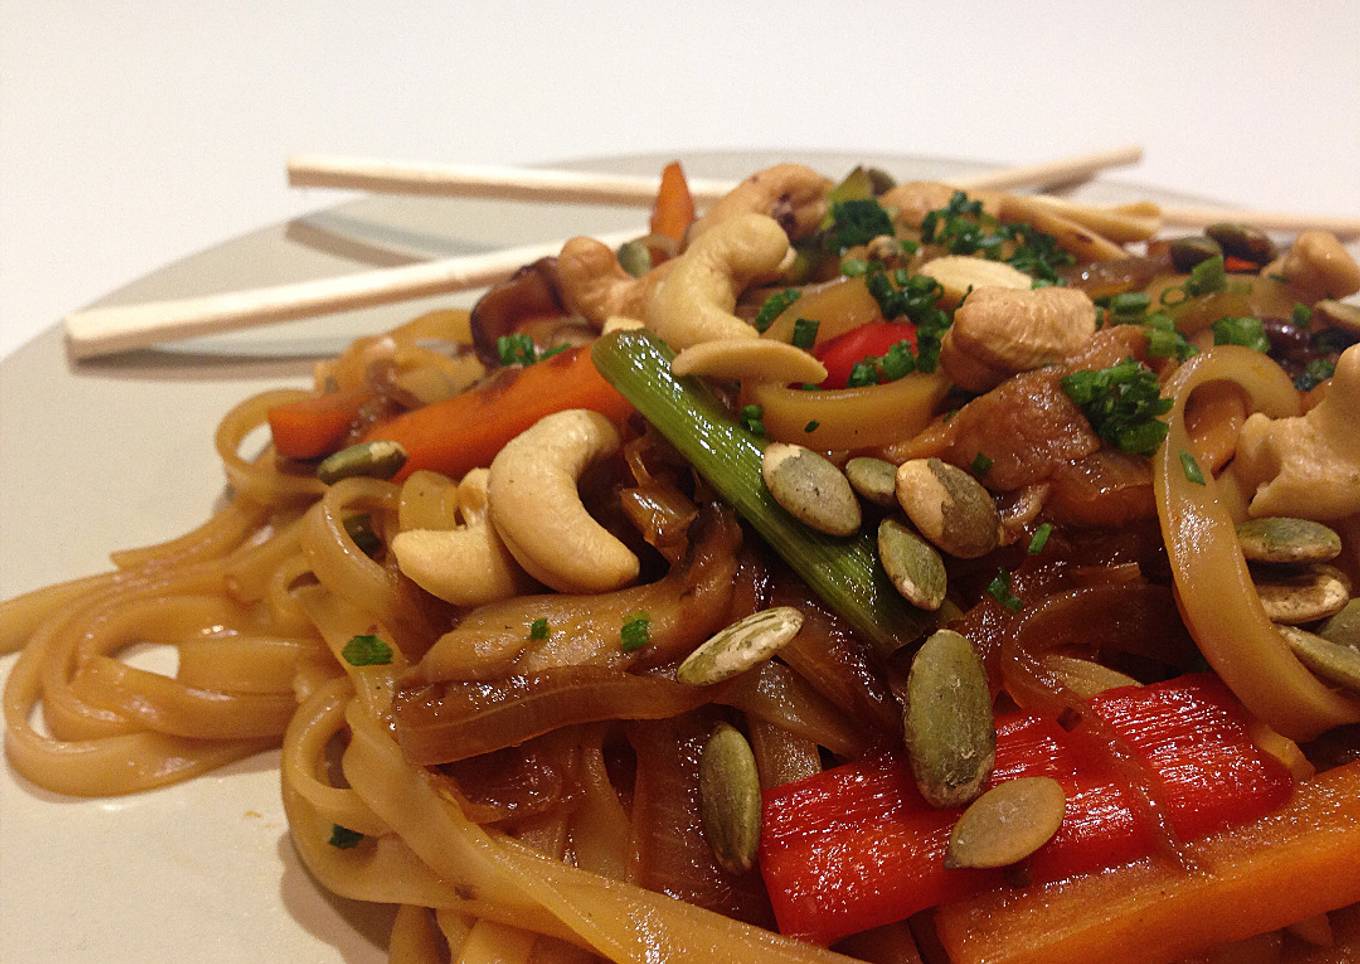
[904,630,997,806]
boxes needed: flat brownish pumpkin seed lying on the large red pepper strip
[944,776,1066,867]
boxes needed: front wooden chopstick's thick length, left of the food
[63,227,646,359]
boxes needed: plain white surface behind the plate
[0,0,1360,356]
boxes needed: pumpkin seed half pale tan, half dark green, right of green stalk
[896,458,1001,559]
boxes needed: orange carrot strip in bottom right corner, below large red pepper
[936,763,1360,964]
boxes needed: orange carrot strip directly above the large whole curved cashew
[364,348,632,481]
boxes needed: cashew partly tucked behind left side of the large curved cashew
[392,469,534,606]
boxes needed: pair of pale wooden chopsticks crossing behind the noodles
[64,147,1360,359]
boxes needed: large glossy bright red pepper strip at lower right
[760,674,1292,944]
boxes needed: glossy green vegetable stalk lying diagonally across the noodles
[592,330,934,654]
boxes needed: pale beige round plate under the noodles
[0,151,1229,963]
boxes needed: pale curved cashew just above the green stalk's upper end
[645,215,793,349]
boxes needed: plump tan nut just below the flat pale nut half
[940,287,1096,392]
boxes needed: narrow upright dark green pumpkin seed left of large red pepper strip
[699,723,760,874]
